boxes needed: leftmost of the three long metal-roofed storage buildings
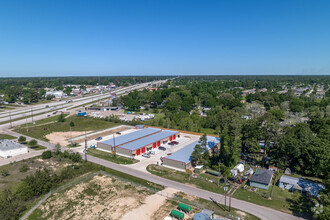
[97,128,162,151]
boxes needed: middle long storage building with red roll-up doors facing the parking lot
[115,128,179,157]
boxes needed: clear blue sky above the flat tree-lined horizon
[0,0,330,77]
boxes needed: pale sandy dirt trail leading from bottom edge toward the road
[121,188,177,220]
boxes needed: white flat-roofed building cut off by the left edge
[0,139,28,158]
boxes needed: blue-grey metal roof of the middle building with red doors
[116,130,179,150]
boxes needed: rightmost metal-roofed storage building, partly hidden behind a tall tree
[163,136,220,171]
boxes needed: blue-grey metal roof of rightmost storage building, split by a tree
[166,136,220,164]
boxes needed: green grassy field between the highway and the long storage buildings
[14,115,120,141]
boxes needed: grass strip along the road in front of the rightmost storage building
[147,164,224,194]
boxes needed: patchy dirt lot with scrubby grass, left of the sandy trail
[32,176,151,220]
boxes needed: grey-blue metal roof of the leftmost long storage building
[101,128,161,146]
